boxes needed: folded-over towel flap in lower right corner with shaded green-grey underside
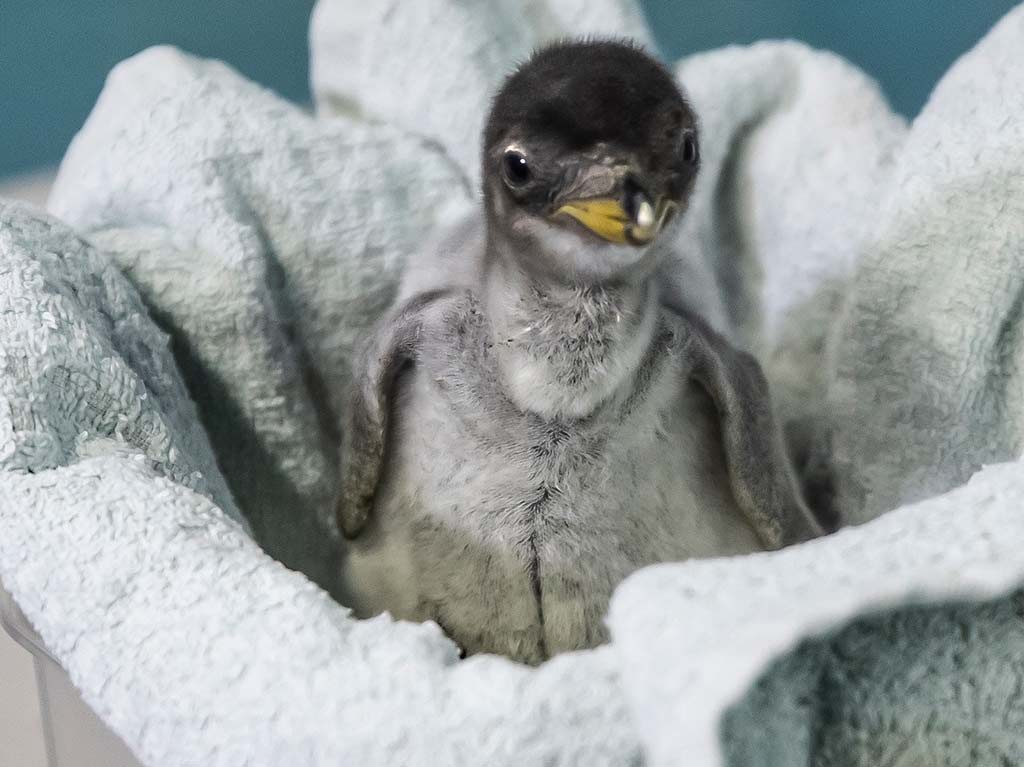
[610,463,1024,767]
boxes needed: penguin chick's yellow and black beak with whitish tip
[551,168,676,247]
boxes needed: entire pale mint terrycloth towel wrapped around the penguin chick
[0,0,1024,767]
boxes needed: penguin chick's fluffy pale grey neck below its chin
[483,237,658,420]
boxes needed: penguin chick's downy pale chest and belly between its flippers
[348,346,758,662]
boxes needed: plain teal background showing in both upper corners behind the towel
[0,0,1024,176]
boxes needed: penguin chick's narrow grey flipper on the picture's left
[336,290,454,540]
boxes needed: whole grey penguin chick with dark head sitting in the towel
[338,41,819,664]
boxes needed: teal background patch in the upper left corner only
[0,0,315,176]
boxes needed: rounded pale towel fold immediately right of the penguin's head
[670,43,906,430]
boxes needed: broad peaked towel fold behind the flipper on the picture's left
[50,48,470,585]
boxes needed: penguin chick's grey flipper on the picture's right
[673,308,823,549]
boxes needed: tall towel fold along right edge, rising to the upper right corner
[829,7,1024,521]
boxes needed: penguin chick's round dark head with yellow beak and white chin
[482,40,699,282]
